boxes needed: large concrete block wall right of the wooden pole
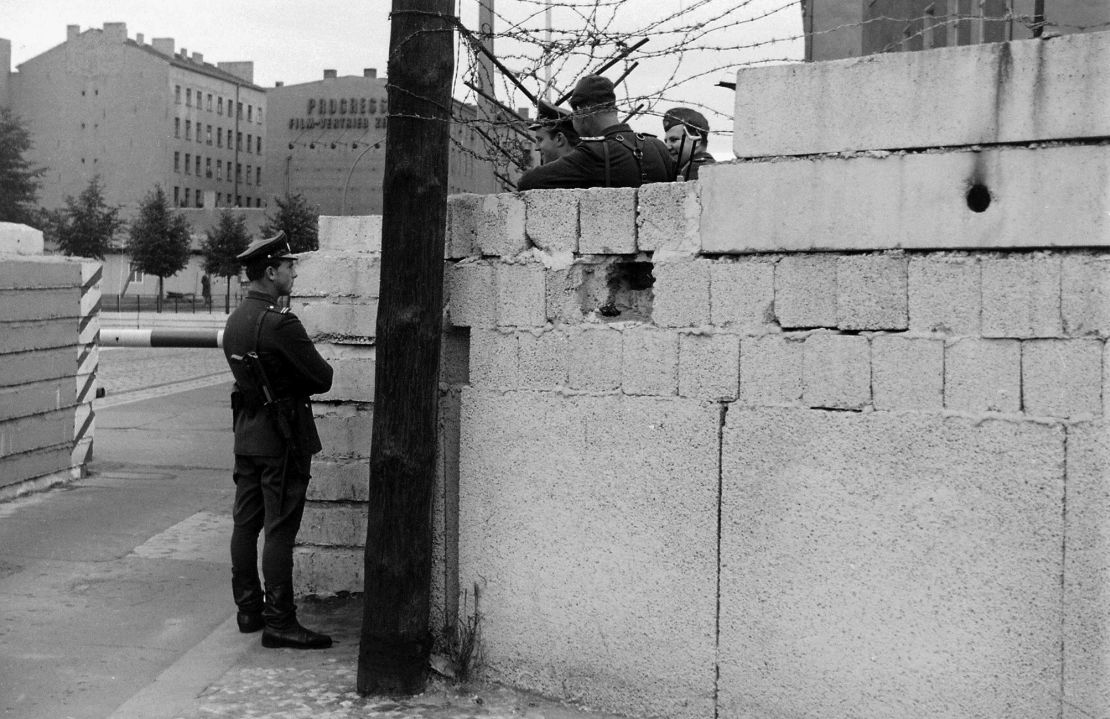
[301,33,1110,718]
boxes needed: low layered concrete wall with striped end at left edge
[0,230,93,499]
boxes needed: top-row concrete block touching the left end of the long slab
[636,182,702,255]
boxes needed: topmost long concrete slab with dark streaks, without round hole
[733,30,1110,158]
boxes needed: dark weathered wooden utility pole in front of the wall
[357,0,454,695]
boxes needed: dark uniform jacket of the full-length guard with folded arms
[223,290,332,456]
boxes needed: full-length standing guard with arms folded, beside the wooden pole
[223,232,332,649]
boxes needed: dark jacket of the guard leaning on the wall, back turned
[516,123,675,191]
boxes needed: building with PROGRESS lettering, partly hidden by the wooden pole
[262,69,502,215]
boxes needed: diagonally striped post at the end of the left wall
[70,262,104,478]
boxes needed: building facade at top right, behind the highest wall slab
[801,0,1110,61]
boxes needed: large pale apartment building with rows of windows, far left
[0,22,269,217]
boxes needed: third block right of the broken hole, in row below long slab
[775,254,837,328]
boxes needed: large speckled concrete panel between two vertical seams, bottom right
[717,408,1065,719]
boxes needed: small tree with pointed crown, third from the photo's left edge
[128,185,189,312]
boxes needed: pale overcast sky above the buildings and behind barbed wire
[0,0,801,158]
